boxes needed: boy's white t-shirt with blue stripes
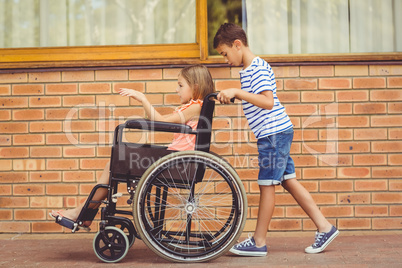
[240,57,293,139]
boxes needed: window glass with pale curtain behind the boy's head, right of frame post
[208,0,402,55]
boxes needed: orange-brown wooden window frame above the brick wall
[0,0,402,69]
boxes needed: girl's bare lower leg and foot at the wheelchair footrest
[52,162,110,226]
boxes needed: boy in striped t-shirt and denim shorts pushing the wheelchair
[214,23,339,256]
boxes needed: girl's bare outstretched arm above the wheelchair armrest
[119,88,201,124]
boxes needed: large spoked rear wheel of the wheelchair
[133,151,247,262]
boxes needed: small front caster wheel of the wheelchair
[93,226,129,263]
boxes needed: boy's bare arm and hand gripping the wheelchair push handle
[218,88,274,110]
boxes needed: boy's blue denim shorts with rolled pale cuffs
[257,128,296,186]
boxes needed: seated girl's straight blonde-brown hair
[179,64,215,100]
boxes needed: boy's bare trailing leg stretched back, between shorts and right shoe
[282,179,332,233]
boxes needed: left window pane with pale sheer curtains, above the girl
[0,0,196,48]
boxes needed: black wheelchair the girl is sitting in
[52,93,247,263]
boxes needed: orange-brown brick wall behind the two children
[0,65,402,233]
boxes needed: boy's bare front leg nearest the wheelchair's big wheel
[253,185,275,247]
